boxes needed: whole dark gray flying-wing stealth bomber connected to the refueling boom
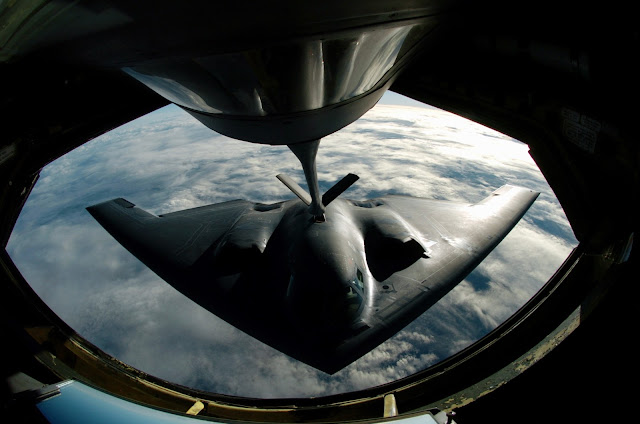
[87,157,539,374]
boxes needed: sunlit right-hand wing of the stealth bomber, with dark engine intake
[318,185,539,372]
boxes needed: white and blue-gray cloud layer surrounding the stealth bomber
[8,96,576,397]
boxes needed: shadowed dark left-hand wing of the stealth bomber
[87,199,304,366]
